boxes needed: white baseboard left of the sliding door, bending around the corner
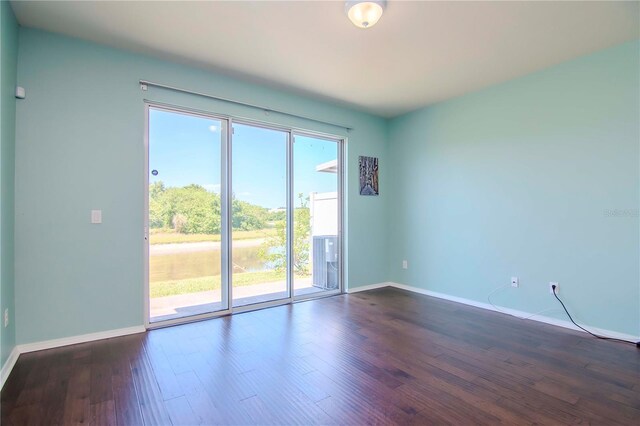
[0,325,146,389]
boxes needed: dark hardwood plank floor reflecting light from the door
[1,289,640,425]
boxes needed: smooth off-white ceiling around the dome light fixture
[12,0,640,117]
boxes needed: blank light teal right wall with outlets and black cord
[389,41,640,336]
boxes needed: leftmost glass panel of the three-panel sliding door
[148,108,228,322]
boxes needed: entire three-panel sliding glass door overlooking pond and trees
[145,105,342,324]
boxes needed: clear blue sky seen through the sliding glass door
[149,109,338,208]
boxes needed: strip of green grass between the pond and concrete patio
[149,271,304,298]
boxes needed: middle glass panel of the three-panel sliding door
[231,124,290,307]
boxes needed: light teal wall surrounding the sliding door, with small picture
[16,28,390,343]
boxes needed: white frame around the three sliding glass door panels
[143,100,346,329]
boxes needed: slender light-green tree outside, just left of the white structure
[259,193,311,275]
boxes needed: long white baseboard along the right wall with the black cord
[389,282,640,342]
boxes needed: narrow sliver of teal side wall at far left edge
[0,1,18,366]
